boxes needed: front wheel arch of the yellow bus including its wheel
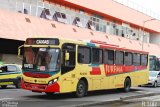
[76,77,88,97]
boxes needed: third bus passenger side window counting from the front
[104,50,114,64]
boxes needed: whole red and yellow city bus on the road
[18,38,149,97]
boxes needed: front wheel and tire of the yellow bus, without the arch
[76,80,87,97]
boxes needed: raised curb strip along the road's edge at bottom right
[73,93,160,107]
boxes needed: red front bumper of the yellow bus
[21,80,60,92]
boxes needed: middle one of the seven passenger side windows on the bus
[115,51,124,65]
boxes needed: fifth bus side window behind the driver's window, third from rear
[124,52,132,65]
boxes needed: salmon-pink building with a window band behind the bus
[0,0,160,64]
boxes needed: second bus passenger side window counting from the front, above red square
[92,48,102,64]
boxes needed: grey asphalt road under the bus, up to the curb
[0,87,160,107]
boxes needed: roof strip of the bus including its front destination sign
[25,37,148,54]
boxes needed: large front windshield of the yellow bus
[23,47,60,71]
